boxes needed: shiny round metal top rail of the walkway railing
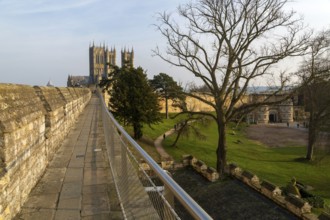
[98,91,212,219]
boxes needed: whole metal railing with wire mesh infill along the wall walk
[98,92,212,219]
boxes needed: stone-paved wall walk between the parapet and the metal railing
[15,95,123,220]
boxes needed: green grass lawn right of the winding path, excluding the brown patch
[156,120,330,204]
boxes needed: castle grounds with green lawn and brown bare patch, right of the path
[163,121,330,211]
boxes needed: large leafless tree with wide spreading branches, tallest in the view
[154,0,309,174]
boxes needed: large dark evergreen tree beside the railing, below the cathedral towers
[110,67,161,139]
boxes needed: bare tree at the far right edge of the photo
[298,30,330,160]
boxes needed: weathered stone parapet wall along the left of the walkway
[0,84,91,220]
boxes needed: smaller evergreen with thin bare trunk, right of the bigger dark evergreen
[150,73,185,119]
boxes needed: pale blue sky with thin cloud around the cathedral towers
[0,0,330,86]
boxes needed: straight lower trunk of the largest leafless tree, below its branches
[216,121,227,176]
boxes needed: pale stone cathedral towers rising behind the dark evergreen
[89,43,134,84]
